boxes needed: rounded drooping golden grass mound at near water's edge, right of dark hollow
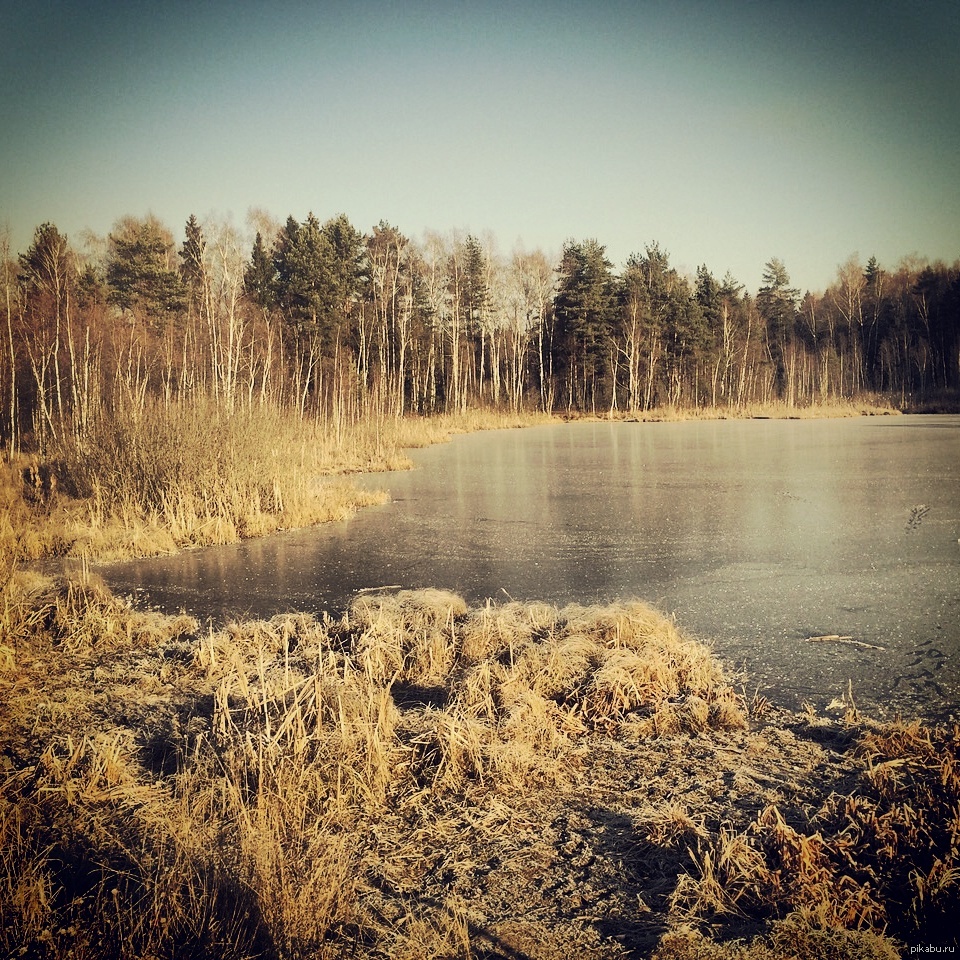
[416,600,745,787]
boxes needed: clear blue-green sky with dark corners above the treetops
[0,0,960,291]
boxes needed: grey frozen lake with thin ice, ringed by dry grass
[103,416,960,718]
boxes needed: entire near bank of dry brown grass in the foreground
[0,572,960,960]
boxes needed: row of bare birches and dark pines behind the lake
[0,214,960,452]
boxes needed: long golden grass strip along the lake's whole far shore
[0,401,900,565]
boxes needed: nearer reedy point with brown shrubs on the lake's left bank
[0,438,386,569]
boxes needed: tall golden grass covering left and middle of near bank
[0,575,756,957]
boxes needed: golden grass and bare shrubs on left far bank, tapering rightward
[0,399,545,568]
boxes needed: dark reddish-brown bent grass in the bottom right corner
[672,721,960,956]
